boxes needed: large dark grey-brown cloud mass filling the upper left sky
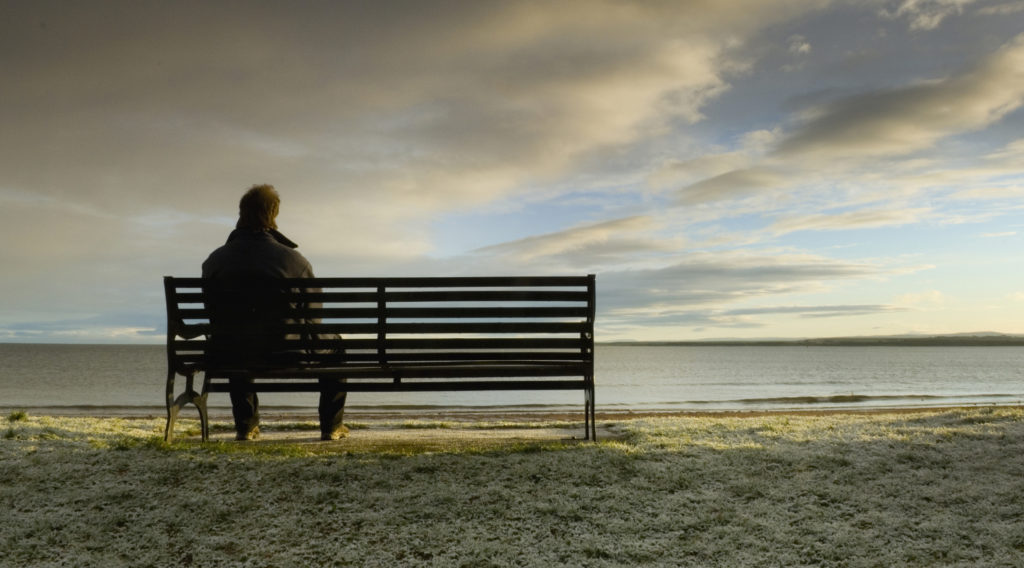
[0,0,835,270]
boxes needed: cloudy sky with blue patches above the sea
[0,0,1024,343]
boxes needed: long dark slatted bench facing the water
[164,274,597,441]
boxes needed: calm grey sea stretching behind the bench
[0,344,1024,416]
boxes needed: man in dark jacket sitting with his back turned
[203,184,348,440]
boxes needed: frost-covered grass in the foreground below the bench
[0,408,1024,566]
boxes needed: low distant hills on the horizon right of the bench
[601,332,1024,347]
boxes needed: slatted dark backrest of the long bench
[164,274,595,376]
